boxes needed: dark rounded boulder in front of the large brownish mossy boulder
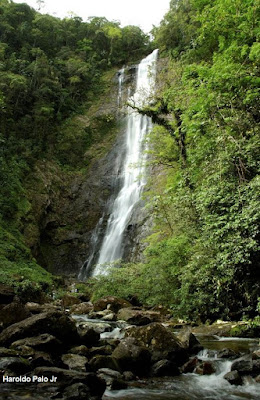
[112,337,151,376]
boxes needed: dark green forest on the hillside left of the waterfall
[0,0,149,288]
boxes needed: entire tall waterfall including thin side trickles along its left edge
[79,50,158,279]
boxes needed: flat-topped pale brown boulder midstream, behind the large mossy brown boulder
[117,307,161,326]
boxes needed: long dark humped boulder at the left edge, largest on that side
[0,311,79,346]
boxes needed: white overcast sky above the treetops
[14,0,170,33]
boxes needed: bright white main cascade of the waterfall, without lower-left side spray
[93,50,158,276]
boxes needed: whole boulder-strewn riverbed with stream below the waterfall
[0,288,260,400]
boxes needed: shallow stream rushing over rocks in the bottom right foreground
[103,335,260,400]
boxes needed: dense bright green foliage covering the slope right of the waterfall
[92,0,260,321]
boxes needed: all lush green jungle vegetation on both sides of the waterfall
[0,0,260,321]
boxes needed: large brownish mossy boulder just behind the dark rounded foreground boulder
[127,322,188,365]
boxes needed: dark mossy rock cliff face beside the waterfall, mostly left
[24,66,150,275]
